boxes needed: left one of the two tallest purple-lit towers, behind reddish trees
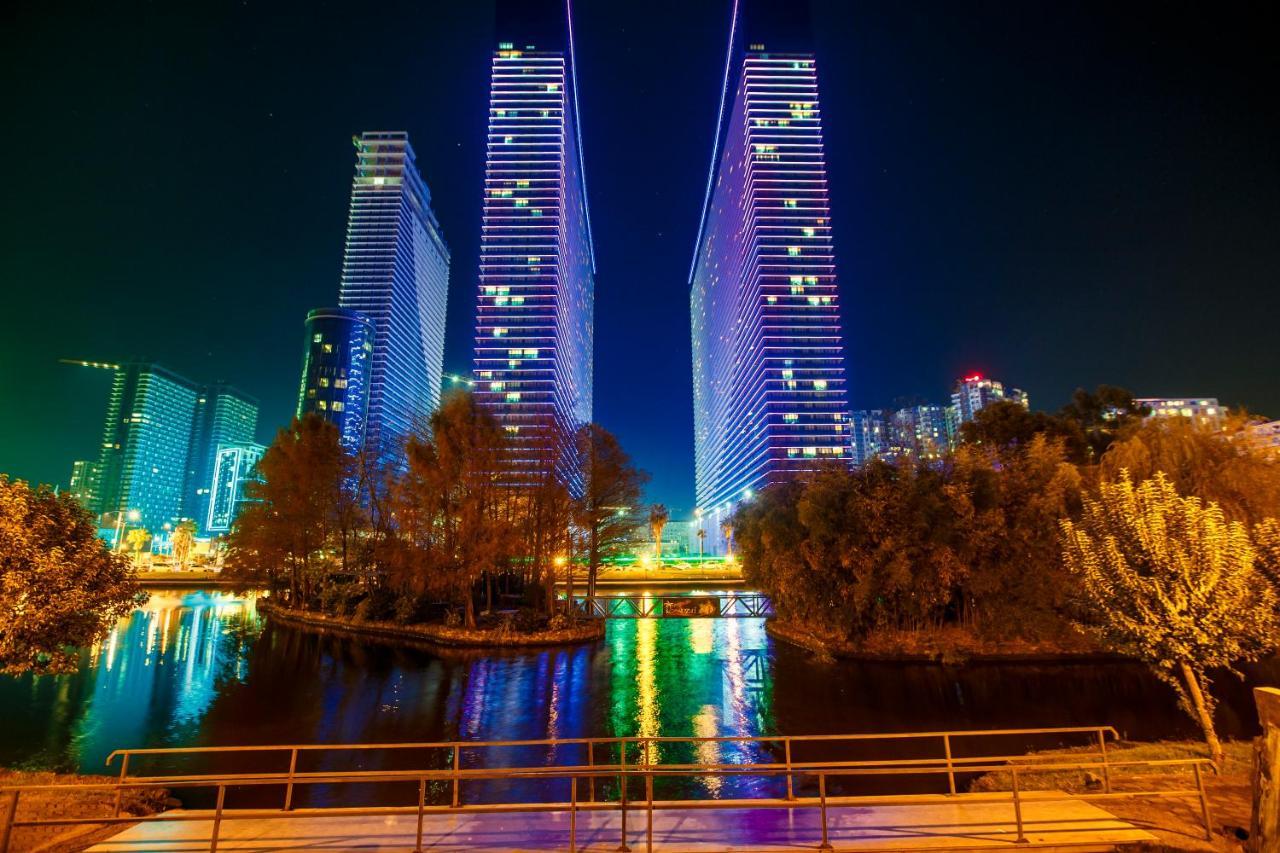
[474,0,595,485]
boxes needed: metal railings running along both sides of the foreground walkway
[0,726,1216,853]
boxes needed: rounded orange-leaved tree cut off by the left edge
[0,475,142,674]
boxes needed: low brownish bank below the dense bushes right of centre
[765,617,1125,663]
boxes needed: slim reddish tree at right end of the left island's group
[572,424,649,596]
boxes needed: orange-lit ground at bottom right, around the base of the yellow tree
[969,740,1252,853]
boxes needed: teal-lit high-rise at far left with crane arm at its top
[93,361,200,533]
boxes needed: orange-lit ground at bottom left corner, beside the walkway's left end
[0,768,170,853]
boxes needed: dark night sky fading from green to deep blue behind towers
[0,0,1280,511]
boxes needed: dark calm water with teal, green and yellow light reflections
[0,590,1280,802]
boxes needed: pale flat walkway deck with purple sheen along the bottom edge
[90,793,1156,853]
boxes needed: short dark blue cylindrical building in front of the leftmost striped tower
[297,309,375,453]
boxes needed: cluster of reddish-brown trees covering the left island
[228,392,645,626]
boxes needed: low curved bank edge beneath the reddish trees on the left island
[257,598,604,648]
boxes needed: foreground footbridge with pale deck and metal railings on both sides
[0,726,1212,853]
